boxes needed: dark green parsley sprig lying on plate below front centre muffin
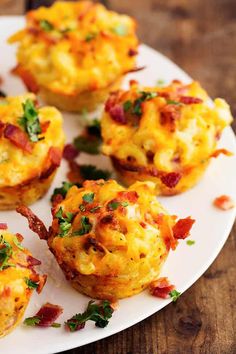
[65,300,114,332]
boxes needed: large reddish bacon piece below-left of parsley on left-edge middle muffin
[4,124,32,153]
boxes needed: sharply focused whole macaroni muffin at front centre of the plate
[45,180,194,300]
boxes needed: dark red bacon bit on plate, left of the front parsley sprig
[35,302,63,327]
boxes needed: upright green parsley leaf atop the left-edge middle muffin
[19,99,42,143]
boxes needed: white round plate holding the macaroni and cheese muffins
[0,17,236,354]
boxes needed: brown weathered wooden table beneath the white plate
[0,0,236,354]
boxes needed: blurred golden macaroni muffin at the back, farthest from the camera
[9,1,138,112]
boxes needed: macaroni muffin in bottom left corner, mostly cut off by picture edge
[0,223,46,337]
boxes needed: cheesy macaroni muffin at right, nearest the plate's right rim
[101,80,232,195]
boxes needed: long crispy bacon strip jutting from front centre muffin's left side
[16,205,48,240]
